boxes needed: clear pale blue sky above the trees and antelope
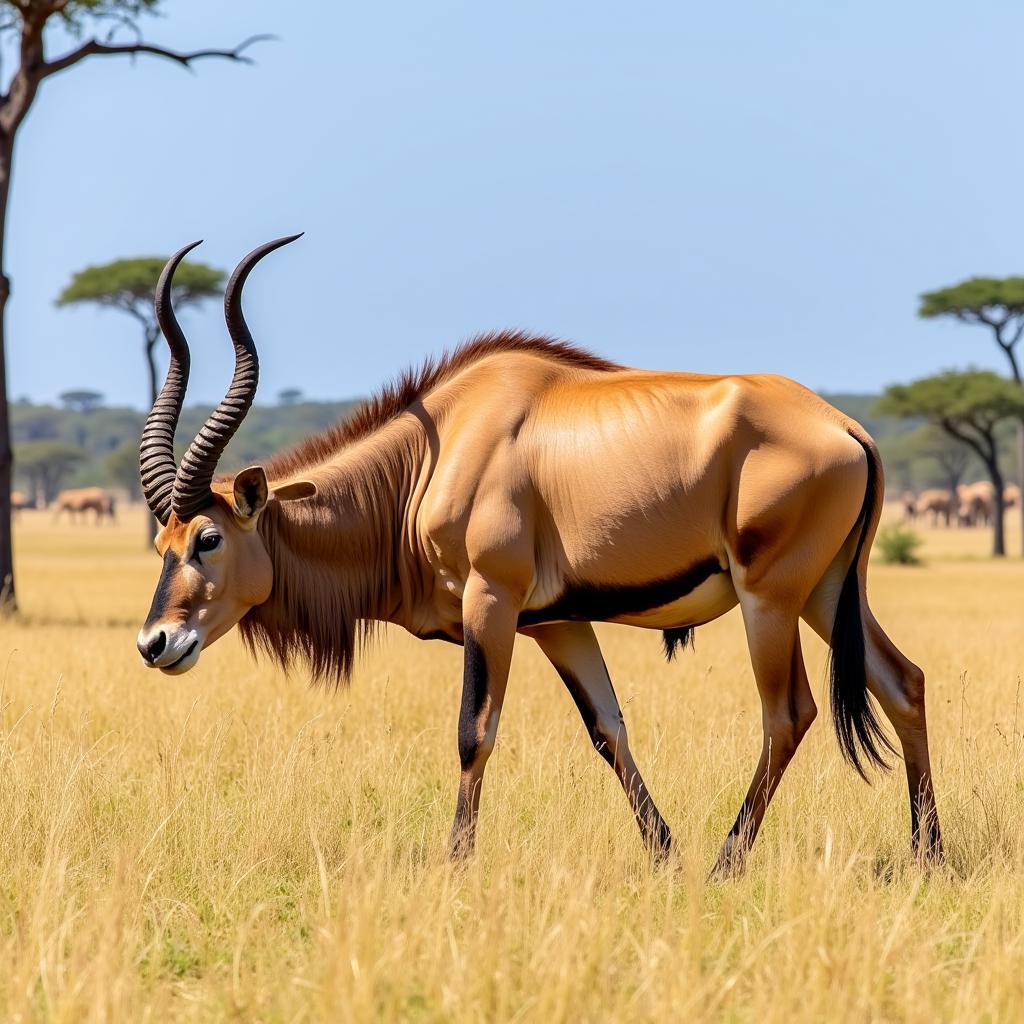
[8,0,1024,404]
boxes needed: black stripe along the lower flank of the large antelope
[519,558,727,627]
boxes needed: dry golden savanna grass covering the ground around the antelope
[0,510,1024,1024]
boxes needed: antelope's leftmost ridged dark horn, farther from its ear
[138,239,203,526]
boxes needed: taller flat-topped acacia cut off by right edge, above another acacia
[918,278,1024,544]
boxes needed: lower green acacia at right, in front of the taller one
[876,370,1024,557]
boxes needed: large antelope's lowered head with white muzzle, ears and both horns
[138,234,316,675]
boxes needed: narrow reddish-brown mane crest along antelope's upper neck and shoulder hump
[265,331,622,480]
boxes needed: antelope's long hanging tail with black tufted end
[828,438,896,781]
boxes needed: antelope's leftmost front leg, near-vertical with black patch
[449,575,519,860]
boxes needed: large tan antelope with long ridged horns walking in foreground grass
[138,236,942,873]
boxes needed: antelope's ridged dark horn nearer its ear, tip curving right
[171,233,302,519]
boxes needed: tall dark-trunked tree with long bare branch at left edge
[0,0,265,611]
